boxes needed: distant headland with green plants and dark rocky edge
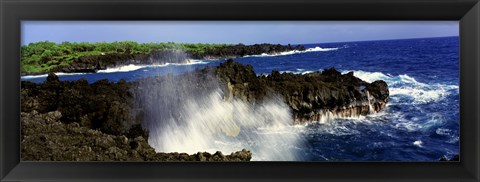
[20,41,305,75]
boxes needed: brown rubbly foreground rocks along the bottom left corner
[21,110,252,161]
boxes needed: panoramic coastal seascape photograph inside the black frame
[20,21,460,162]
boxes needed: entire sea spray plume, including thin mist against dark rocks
[138,68,305,161]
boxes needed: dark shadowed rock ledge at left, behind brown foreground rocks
[20,73,141,138]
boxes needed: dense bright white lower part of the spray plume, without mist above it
[144,86,302,161]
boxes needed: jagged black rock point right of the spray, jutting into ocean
[217,60,389,123]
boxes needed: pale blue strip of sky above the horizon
[21,21,459,45]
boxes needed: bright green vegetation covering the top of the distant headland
[20,41,232,74]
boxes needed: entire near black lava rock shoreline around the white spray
[21,60,389,161]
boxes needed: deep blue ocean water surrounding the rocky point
[22,37,459,161]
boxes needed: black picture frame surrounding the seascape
[0,0,480,182]
